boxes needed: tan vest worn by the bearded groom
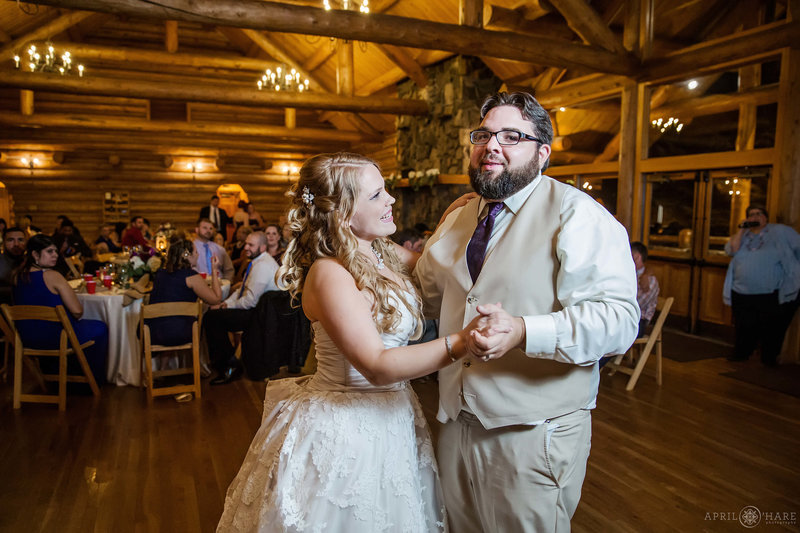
[426,176,598,429]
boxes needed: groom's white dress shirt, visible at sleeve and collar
[422,175,639,425]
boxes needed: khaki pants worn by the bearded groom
[438,410,592,533]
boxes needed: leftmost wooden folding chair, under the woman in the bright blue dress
[2,304,100,411]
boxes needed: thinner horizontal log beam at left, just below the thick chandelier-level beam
[0,111,381,142]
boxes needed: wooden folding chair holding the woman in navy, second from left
[139,300,203,401]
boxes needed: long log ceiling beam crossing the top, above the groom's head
[26,0,636,75]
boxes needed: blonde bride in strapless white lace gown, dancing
[217,153,506,533]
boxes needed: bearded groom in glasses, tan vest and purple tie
[414,89,639,533]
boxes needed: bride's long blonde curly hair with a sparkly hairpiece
[276,152,422,335]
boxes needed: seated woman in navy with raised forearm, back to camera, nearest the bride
[145,237,222,346]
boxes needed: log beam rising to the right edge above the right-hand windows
[639,21,800,83]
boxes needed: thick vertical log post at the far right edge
[768,48,800,229]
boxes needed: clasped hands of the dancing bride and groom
[464,302,525,361]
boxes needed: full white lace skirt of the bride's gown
[217,377,446,533]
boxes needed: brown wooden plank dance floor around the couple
[0,332,800,533]
